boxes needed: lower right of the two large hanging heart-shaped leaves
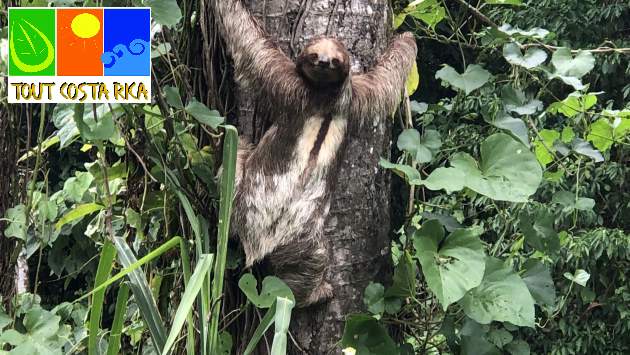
[462,257,534,328]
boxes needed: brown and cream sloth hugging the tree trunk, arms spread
[212,0,417,307]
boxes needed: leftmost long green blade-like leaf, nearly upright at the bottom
[88,239,116,355]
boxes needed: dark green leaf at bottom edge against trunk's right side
[341,314,398,355]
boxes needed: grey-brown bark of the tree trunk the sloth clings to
[202,0,392,354]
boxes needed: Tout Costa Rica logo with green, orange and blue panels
[8,7,151,103]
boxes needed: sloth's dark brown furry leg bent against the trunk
[269,240,333,307]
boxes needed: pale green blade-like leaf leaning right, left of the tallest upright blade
[162,254,214,355]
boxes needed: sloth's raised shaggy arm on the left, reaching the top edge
[211,0,304,105]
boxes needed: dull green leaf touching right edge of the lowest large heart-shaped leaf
[522,259,556,308]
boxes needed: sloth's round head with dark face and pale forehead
[297,37,350,88]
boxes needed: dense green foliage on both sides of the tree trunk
[0,0,630,354]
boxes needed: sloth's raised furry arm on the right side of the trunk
[351,32,417,119]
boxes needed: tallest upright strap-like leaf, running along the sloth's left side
[210,126,238,352]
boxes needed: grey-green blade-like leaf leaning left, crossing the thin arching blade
[114,238,166,351]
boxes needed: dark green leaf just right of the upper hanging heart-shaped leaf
[518,206,560,254]
